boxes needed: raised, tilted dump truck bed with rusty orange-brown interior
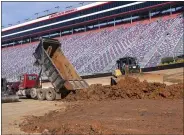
[33,38,88,100]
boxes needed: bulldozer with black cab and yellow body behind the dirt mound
[111,57,141,85]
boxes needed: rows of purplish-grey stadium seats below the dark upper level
[2,15,184,81]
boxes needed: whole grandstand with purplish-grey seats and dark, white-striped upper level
[2,1,184,80]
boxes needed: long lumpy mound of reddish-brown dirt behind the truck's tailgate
[64,77,183,101]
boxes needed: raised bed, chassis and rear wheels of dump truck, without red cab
[16,38,89,101]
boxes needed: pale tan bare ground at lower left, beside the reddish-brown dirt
[2,99,65,134]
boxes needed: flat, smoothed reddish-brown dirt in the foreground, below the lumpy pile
[20,99,183,134]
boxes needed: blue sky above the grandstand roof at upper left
[2,2,91,27]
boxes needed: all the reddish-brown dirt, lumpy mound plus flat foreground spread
[19,77,183,134]
